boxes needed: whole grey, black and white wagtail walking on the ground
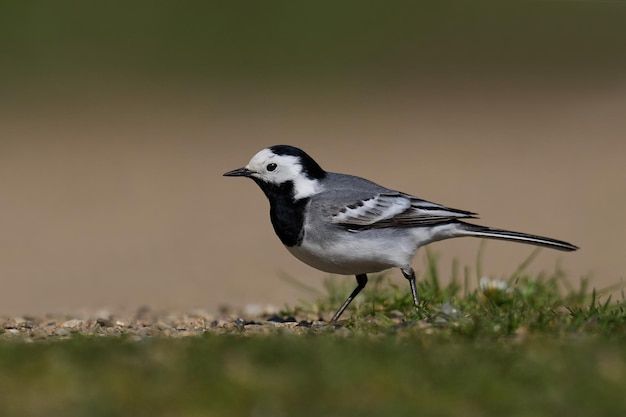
[224,145,578,321]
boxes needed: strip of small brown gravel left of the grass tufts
[0,306,348,342]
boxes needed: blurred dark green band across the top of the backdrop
[0,0,626,91]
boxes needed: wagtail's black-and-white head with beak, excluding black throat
[224,145,326,200]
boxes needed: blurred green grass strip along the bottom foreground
[0,335,626,417]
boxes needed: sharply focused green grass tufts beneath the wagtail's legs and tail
[285,249,626,340]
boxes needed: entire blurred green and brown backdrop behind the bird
[0,0,626,314]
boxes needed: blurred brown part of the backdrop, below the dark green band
[0,83,626,313]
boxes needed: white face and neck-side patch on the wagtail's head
[246,149,322,200]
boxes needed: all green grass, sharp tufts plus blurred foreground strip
[0,250,626,417]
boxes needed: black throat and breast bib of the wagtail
[253,178,309,247]
